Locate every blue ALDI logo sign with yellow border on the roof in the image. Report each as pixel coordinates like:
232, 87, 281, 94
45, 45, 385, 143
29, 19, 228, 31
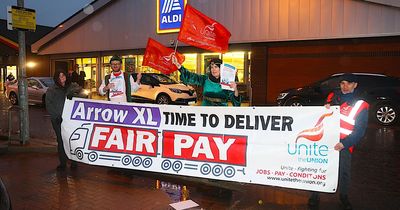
157, 0, 187, 33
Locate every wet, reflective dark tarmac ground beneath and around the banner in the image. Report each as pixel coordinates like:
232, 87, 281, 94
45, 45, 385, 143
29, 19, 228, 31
0, 92, 400, 210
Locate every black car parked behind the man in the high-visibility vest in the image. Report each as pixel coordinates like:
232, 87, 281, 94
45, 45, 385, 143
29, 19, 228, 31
277, 73, 400, 125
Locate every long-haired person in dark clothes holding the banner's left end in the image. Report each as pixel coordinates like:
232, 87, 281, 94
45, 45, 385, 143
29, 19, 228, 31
46, 70, 82, 170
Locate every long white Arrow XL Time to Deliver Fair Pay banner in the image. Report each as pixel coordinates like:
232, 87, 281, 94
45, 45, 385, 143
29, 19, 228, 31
62, 99, 339, 192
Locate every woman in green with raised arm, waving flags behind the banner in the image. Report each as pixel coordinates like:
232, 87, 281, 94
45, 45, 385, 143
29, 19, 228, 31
172, 56, 242, 106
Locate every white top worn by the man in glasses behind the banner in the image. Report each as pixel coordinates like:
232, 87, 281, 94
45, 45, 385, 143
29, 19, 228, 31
99, 73, 139, 102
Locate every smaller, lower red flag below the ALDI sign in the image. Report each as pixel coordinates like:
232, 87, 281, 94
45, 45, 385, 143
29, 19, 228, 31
142, 38, 185, 74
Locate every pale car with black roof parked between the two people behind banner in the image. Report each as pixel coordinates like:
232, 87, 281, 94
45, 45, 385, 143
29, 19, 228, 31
132, 73, 197, 105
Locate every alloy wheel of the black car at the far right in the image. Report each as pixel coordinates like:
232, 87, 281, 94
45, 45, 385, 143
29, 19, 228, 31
374, 103, 398, 125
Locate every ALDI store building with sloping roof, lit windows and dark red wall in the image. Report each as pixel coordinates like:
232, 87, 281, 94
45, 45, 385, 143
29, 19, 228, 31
32, 0, 400, 105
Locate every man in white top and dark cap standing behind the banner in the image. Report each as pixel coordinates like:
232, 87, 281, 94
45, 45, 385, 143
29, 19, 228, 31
99, 55, 142, 102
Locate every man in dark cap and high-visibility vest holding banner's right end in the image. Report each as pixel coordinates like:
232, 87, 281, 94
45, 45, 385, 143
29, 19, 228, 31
308, 73, 369, 210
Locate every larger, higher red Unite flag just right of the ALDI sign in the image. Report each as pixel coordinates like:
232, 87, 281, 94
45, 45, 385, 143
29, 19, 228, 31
178, 5, 231, 53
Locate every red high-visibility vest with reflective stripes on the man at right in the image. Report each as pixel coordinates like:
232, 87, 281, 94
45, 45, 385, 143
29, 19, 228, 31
340, 100, 369, 152
